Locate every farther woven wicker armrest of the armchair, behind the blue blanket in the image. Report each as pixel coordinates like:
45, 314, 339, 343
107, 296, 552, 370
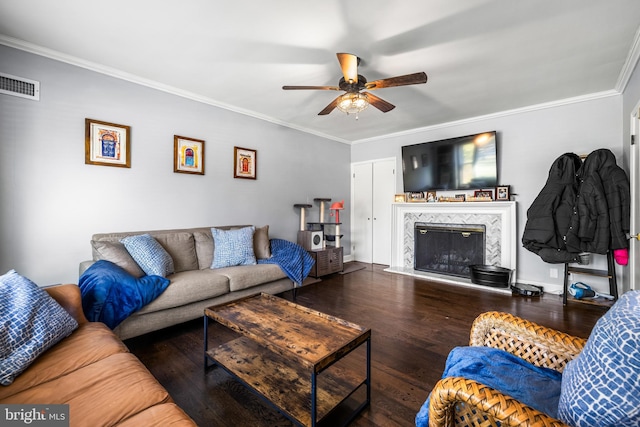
469, 311, 587, 372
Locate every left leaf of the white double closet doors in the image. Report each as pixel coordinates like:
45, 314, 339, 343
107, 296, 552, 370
351, 163, 373, 264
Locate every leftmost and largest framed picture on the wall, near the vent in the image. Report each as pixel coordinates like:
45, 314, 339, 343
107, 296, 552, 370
84, 119, 131, 168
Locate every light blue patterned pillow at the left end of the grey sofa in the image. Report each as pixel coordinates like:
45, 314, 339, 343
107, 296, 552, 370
120, 234, 175, 277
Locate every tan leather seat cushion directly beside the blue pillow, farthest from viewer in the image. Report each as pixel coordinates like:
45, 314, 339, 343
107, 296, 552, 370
0, 322, 129, 401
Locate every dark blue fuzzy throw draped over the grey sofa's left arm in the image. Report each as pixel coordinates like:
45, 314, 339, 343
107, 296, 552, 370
78, 260, 171, 329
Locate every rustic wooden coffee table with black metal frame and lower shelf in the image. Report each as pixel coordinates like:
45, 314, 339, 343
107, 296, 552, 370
204, 293, 371, 426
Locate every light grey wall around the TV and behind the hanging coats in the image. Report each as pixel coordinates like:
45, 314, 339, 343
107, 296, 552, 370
351, 95, 623, 289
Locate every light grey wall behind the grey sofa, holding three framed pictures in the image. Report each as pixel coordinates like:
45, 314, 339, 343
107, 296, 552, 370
0, 46, 350, 285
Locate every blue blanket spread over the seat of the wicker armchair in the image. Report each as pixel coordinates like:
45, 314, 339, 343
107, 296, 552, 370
416, 347, 562, 427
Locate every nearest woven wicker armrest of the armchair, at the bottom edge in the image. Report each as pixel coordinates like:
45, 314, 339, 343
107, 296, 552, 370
429, 377, 568, 427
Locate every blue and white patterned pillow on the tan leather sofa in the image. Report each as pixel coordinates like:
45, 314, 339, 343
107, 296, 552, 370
0, 270, 78, 386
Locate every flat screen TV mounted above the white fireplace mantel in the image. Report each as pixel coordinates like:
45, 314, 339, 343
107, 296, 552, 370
402, 131, 498, 192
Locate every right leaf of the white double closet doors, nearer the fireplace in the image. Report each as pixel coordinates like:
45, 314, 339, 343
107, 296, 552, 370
373, 160, 396, 265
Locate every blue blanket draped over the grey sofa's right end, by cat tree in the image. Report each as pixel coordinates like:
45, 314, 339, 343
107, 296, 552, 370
258, 239, 314, 286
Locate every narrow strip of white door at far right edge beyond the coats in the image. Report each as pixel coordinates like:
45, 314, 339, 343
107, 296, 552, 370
629, 104, 640, 290
